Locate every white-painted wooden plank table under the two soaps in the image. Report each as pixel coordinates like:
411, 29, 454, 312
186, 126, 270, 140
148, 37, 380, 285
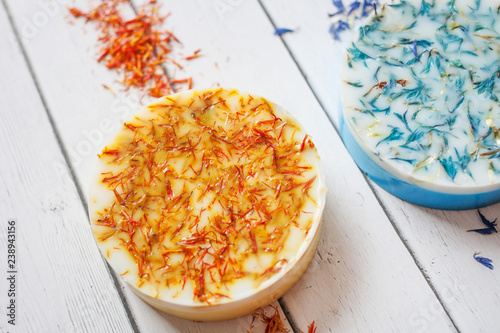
0, 0, 500, 333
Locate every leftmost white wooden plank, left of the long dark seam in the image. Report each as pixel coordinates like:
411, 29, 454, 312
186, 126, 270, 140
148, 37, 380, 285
0, 6, 133, 332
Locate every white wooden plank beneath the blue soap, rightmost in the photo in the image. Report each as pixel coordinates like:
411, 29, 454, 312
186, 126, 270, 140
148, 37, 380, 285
262, 0, 500, 332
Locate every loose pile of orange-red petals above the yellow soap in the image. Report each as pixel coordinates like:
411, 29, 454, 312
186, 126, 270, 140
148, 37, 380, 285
69, 0, 200, 97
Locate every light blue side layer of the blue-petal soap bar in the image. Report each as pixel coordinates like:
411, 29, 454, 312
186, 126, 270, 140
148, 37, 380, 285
339, 110, 500, 210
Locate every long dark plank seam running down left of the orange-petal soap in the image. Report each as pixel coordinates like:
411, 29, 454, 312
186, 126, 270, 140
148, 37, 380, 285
1, 0, 140, 333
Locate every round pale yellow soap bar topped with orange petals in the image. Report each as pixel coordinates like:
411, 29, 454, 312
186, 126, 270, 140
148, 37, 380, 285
89, 88, 326, 321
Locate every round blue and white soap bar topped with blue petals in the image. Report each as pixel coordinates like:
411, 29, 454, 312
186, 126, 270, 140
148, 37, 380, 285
340, 0, 500, 210
